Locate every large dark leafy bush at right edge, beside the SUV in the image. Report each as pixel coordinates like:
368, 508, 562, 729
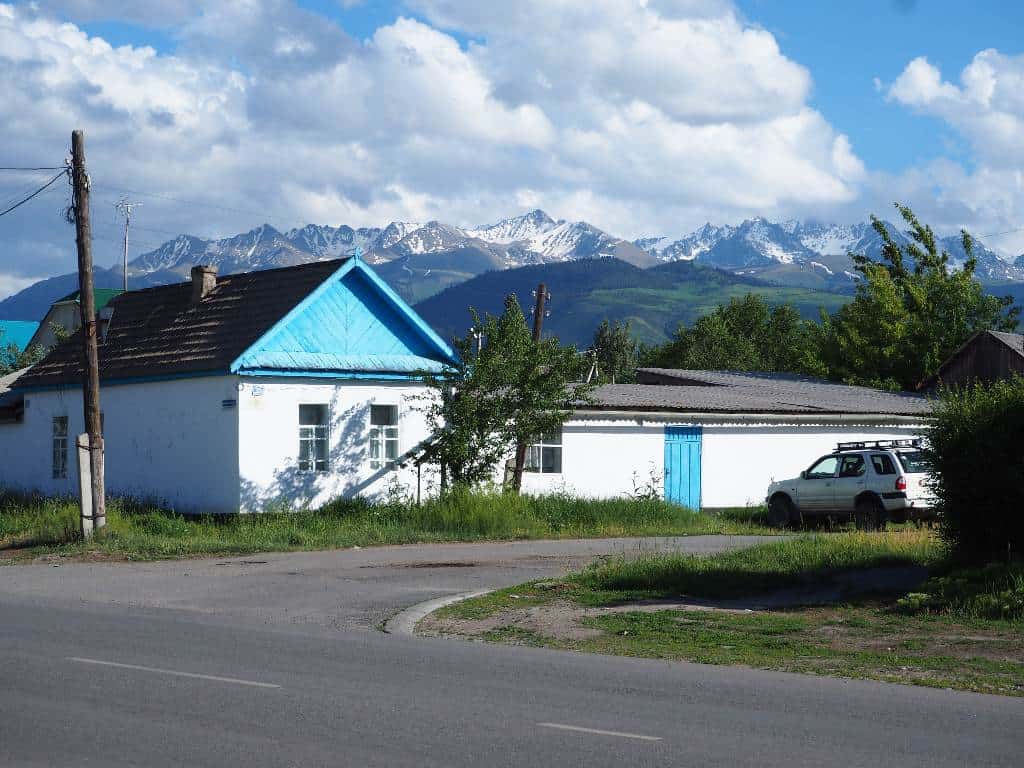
928, 377, 1024, 563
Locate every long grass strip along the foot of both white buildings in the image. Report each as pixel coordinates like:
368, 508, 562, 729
0, 493, 770, 561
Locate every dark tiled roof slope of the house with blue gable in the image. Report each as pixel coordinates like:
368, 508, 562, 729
17, 260, 342, 388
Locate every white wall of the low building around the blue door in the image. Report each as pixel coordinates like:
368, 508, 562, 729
523, 418, 922, 508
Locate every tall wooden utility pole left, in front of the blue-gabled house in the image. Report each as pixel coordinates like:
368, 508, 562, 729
71, 130, 106, 536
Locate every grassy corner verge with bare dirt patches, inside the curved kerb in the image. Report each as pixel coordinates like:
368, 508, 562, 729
420, 530, 1024, 695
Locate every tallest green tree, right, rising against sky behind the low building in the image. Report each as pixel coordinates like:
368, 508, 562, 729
818, 203, 1020, 389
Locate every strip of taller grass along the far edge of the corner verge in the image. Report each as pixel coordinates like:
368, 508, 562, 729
577, 530, 945, 597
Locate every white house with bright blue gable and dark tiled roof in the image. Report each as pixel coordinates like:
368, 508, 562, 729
0, 257, 455, 512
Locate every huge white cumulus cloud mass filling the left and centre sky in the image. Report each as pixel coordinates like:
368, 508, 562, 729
0, 0, 866, 296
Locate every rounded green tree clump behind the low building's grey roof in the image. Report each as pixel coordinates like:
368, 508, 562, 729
642, 294, 820, 373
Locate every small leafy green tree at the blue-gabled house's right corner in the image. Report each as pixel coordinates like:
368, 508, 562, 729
417, 295, 591, 489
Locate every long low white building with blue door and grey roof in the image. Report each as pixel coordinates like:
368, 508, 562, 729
523, 369, 930, 508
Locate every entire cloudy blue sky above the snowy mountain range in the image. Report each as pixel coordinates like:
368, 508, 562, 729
0, 0, 1024, 296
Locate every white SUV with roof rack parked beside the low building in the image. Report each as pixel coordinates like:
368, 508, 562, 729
766, 440, 934, 530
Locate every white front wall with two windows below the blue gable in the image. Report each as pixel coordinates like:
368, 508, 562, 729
239, 377, 436, 512
